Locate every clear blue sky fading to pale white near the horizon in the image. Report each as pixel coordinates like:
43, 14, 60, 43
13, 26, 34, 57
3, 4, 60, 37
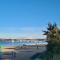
0, 0, 60, 38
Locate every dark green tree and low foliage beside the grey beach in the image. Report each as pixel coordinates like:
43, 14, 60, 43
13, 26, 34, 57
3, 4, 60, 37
32, 23, 60, 60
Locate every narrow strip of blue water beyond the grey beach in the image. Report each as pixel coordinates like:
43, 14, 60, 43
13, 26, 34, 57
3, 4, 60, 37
0, 41, 48, 47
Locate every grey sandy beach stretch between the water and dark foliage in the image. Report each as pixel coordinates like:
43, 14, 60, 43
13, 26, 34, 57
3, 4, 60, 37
15, 46, 46, 60
